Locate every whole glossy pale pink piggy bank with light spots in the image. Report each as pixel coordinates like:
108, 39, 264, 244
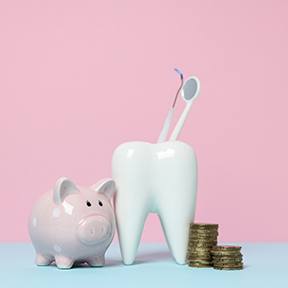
29, 177, 116, 269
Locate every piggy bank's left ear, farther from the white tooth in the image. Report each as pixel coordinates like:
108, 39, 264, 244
53, 177, 79, 204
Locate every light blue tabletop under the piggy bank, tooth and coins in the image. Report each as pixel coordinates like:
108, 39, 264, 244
0, 243, 288, 288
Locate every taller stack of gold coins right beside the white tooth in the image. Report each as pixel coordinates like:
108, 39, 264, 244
186, 223, 218, 267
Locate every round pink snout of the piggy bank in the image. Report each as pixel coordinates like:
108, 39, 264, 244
77, 215, 112, 245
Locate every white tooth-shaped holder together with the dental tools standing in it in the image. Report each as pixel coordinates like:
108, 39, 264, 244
112, 74, 199, 264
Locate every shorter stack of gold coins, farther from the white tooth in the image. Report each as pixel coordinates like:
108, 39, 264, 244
211, 246, 243, 270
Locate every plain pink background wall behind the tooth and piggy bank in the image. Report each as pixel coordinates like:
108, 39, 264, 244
0, 0, 288, 241
